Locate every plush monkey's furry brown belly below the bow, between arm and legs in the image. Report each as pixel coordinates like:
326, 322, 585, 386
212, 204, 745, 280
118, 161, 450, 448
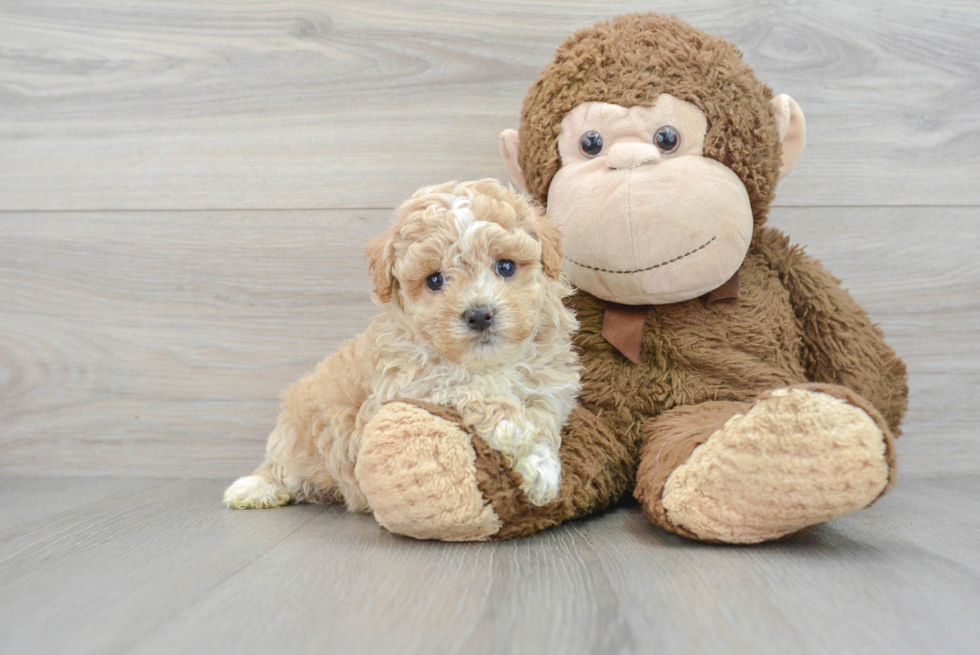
572, 252, 805, 419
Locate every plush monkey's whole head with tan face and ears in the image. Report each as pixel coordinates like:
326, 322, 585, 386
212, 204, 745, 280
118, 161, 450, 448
501, 13, 806, 305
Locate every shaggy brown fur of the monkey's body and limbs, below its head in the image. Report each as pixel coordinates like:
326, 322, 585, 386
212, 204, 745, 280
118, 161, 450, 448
466, 228, 908, 539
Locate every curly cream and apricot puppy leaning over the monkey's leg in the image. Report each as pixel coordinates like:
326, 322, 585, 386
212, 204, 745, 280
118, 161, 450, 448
224, 179, 579, 511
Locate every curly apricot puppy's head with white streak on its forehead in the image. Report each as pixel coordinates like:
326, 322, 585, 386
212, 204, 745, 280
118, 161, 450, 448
367, 179, 570, 364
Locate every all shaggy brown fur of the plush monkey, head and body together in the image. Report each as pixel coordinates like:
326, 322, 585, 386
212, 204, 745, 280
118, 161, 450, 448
475, 14, 908, 538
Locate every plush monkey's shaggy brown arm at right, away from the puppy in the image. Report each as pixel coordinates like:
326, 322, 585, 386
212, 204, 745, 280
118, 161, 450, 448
756, 228, 908, 436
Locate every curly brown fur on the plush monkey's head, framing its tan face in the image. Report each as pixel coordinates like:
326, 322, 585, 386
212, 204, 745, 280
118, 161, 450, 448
519, 13, 779, 226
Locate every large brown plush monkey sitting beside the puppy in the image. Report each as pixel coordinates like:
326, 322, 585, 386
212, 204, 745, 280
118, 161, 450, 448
358, 14, 907, 543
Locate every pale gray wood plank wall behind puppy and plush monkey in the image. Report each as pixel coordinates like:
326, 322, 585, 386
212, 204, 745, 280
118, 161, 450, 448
0, 0, 980, 477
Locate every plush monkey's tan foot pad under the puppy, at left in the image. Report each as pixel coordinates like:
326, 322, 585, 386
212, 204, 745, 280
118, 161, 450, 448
354, 402, 501, 541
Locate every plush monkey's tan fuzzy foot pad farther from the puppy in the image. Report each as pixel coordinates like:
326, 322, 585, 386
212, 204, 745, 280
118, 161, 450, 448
663, 388, 889, 543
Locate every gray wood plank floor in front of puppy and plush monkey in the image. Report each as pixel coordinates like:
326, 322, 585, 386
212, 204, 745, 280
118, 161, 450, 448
0, 476, 980, 654
